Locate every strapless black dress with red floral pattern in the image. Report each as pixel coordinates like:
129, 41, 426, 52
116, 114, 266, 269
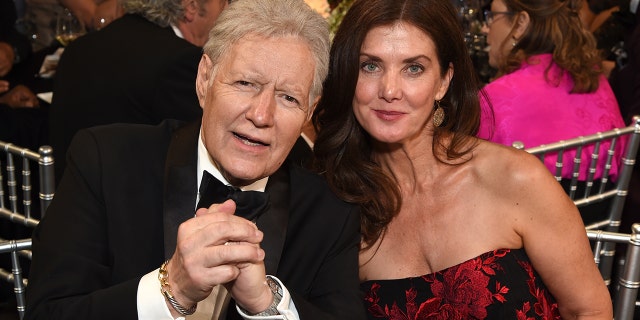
360, 249, 560, 320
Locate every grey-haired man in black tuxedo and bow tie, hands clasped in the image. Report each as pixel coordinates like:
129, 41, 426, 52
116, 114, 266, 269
26, 0, 364, 320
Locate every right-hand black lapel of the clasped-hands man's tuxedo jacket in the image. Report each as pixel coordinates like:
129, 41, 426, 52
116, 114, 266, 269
256, 162, 291, 275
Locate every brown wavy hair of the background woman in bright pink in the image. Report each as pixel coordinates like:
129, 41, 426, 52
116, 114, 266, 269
498, 0, 602, 93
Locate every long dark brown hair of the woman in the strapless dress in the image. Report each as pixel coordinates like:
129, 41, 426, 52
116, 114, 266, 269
312, 0, 480, 248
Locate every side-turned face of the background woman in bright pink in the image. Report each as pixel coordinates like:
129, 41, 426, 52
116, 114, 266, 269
484, 0, 515, 68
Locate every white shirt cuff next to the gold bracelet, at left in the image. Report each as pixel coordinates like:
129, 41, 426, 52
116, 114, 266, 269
137, 269, 184, 320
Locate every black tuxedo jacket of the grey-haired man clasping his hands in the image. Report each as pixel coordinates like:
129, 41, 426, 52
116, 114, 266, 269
27, 121, 364, 320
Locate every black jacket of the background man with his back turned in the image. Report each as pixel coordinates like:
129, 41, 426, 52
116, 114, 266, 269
49, 14, 202, 181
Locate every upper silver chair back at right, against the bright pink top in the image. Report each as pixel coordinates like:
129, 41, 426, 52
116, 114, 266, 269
512, 116, 640, 285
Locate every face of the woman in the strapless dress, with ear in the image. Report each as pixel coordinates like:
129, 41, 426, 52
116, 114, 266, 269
353, 23, 453, 143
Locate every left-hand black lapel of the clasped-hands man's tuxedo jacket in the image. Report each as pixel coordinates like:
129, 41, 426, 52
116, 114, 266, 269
163, 122, 200, 259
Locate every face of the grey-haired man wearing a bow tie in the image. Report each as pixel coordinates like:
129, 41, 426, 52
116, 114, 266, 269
196, 36, 318, 185
